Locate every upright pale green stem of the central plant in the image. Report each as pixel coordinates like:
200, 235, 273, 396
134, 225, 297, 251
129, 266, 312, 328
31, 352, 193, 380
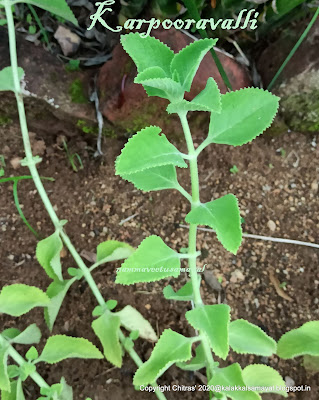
179, 113, 215, 381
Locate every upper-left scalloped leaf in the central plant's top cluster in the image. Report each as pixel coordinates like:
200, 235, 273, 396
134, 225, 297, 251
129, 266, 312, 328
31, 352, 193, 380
121, 32, 174, 77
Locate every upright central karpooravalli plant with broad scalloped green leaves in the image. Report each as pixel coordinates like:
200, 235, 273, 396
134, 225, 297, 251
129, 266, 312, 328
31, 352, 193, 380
115, 33, 319, 400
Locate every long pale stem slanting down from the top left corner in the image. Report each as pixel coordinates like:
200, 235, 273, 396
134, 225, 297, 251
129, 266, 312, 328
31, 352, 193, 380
3, 0, 165, 400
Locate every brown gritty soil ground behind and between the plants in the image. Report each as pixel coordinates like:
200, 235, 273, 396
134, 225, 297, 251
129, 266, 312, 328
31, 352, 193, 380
0, 124, 319, 400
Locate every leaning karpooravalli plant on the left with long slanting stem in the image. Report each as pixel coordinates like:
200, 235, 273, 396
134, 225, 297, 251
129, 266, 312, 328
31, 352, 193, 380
0, 0, 164, 400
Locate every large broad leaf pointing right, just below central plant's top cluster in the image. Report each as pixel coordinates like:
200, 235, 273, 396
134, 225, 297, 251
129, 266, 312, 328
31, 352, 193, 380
207, 88, 279, 146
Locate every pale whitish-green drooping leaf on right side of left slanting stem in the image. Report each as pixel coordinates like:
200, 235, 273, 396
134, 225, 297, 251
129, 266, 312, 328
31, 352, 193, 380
114, 306, 157, 342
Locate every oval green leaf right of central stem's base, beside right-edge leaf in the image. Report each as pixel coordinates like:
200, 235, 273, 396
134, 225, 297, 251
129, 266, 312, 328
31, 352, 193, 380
229, 319, 277, 357
